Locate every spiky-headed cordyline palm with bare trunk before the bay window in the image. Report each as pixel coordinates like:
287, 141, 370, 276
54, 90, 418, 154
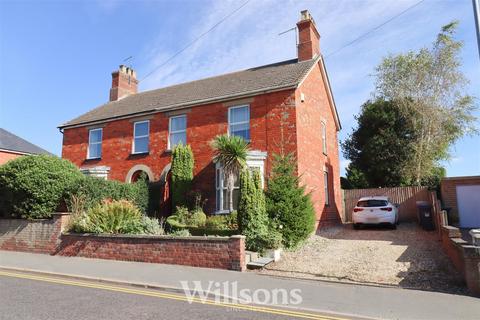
211, 135, 249, 212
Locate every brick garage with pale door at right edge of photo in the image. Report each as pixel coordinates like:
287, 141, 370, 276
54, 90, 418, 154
440, 176, 480, 229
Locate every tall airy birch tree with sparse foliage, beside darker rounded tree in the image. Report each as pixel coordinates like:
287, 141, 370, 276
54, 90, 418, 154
375, 22, 477, 185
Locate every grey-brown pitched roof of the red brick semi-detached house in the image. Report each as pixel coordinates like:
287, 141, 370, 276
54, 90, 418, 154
60, 59, 318, 128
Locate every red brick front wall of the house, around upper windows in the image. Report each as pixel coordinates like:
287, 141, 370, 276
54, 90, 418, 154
62, 90, 296, 212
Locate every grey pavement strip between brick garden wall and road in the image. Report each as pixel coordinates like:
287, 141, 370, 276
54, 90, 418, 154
0, 251, 480, 319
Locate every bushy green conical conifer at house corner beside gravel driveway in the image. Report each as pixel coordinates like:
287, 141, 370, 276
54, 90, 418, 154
266, 154, 315, 248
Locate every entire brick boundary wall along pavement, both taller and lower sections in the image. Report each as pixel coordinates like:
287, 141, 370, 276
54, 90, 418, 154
0, 213, 246, 271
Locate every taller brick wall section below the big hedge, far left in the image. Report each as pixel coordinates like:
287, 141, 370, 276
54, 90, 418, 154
0, 214, 68, 253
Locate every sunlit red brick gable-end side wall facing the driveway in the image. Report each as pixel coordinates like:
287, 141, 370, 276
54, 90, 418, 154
296, 64, 342, 223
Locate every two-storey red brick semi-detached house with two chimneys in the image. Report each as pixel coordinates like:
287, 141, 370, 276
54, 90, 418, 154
59, 11, 342, 223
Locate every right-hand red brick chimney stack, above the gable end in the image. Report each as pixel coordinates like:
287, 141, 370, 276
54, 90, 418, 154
297, 10, 320, 61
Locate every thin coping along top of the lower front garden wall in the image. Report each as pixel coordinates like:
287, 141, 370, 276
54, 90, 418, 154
62, 232, 245, 242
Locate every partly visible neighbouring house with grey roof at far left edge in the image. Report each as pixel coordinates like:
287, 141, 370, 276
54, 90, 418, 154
0, 128, 50, 165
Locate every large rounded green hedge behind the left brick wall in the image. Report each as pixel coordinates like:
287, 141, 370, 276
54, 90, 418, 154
0, 155, 149, 219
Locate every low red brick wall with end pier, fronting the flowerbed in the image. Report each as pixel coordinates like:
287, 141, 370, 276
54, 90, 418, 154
58, 234, 246, 271
